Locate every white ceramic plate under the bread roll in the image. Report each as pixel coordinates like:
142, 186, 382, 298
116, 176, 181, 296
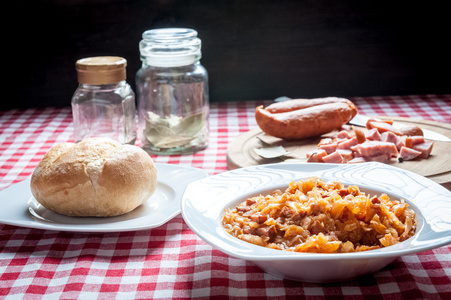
0, 163, 208, 232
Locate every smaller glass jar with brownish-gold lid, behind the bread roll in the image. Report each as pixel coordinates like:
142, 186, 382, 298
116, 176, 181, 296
72, 56, 136, 145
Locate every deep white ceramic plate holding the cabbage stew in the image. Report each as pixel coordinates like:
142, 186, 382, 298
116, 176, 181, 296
182, 162, 451, 282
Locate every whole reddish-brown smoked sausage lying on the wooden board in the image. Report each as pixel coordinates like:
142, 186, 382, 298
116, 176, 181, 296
255, 97, 357, 139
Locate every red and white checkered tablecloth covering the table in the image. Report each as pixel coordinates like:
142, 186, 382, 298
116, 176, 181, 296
0, 95, 451, 299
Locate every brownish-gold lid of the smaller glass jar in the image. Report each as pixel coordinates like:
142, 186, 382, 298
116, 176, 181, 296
75, 56, 127, 84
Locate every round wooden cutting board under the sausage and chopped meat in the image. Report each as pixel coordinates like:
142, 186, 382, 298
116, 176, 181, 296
227, 116, 451, 189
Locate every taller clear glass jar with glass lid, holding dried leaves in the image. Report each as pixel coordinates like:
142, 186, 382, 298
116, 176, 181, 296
136, 28, 209, 155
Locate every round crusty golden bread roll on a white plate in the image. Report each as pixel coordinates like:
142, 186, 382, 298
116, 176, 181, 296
30, 138, 157, 217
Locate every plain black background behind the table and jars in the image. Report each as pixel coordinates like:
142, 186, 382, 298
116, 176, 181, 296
4, 0, 451, 110
